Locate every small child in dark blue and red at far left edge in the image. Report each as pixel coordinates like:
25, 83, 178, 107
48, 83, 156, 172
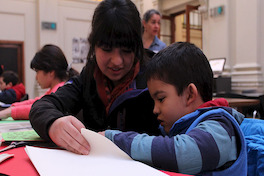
0, 71, 25, 104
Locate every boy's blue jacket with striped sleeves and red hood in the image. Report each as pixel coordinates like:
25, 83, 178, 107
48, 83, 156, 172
105, 89, 247, 176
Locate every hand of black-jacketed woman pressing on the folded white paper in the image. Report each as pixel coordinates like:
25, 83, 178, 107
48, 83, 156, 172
49, 116, 90, 155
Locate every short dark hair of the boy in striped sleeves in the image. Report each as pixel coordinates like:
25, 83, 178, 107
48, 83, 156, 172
146, 42, 213, 102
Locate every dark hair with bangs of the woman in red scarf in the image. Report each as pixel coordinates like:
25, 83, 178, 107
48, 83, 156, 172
87, 0, 144, 62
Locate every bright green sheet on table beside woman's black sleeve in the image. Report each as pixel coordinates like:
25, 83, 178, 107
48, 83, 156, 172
2, 130, 43, 141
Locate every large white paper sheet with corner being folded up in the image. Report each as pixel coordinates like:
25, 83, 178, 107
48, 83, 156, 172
25, 129, 166, 176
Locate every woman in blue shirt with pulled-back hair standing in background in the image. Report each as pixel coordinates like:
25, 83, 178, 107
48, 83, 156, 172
142, 9, 166, 53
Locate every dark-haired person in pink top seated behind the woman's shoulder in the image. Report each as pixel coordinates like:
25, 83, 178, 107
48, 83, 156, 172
0, 45, 77, 120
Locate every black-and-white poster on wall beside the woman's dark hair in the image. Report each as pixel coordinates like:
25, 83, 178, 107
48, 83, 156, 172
72, 38, 89, 64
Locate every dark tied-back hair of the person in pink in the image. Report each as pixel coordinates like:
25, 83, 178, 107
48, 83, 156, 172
30, 44, 78, 81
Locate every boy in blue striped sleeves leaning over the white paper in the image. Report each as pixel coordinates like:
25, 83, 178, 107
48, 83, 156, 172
101, 42, 247, 176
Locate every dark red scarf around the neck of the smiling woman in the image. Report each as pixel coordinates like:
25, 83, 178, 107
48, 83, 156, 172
94, 62, 140, 114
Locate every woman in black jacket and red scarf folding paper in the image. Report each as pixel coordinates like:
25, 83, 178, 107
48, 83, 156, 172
29, 0, 158, 154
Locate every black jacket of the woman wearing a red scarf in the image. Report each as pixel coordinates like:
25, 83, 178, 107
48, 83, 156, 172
29, 62, 159, 140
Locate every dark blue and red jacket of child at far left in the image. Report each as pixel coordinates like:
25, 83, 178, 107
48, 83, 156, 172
0, 83, 25, 104
